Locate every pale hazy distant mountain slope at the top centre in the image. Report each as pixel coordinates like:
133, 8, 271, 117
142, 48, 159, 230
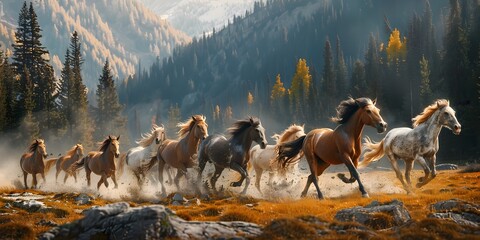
137, 0, 255, 36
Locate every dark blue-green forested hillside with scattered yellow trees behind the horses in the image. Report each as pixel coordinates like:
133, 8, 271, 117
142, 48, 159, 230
120, 0, 480, 161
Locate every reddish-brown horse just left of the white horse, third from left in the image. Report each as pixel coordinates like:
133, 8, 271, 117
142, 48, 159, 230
69, 136, 120, 189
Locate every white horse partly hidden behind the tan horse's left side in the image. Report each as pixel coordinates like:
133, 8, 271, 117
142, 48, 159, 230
119, 124, 166, 186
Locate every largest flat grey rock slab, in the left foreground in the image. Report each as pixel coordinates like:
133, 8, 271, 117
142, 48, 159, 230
39, 202, 261, 239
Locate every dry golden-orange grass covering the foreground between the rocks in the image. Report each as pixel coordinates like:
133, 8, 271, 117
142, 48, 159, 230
0, 171, 480, 239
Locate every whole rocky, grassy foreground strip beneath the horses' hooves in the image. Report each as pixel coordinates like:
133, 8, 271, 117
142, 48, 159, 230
0, 164, 480, 239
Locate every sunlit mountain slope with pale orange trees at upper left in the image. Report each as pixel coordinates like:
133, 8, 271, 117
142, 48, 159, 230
0, 0, 190, 87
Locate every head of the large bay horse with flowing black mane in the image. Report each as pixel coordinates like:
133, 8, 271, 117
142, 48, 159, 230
355, 99, 387, 133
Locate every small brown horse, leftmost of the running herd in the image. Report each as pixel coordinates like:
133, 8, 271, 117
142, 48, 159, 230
20, 139, 56, 189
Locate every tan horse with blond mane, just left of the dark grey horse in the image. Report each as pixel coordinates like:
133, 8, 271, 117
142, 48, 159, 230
153, 115, 208, 193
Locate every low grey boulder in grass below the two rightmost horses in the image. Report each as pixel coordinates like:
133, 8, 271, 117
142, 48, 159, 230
335, 200, 411, 229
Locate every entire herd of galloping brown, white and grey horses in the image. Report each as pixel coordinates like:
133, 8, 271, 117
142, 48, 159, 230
20, 98, 461, 199
